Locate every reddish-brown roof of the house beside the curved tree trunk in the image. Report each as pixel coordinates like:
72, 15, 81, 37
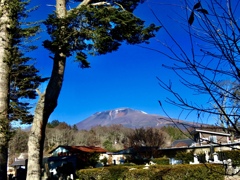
49, 146, 107, 154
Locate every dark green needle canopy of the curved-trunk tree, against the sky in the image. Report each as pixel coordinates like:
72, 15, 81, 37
43, 1, 159, 68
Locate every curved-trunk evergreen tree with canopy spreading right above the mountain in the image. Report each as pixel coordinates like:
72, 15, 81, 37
27, 0, 159, 180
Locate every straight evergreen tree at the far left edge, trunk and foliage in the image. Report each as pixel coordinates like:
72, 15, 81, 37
0, 0, 46, 180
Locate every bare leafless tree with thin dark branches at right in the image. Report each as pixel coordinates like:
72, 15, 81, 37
145, 0, 240, 137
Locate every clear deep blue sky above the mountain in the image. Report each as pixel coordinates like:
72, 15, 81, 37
19, 0, 212, 125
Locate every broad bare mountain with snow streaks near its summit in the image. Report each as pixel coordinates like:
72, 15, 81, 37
76, 108, 199, 130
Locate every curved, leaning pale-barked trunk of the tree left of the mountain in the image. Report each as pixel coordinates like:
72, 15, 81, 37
27, 0, 66, 180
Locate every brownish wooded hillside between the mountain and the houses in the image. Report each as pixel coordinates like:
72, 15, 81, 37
9, 120, 189, 164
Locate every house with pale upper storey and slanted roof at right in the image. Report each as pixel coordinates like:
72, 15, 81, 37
159, 128, 240, 157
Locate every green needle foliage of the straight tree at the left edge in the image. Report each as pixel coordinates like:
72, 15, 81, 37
6, 0, 47, 123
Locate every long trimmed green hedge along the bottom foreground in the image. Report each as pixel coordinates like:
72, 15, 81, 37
77, 164, 224, 180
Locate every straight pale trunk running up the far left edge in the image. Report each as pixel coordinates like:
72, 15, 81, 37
0, 0, 9, 180
